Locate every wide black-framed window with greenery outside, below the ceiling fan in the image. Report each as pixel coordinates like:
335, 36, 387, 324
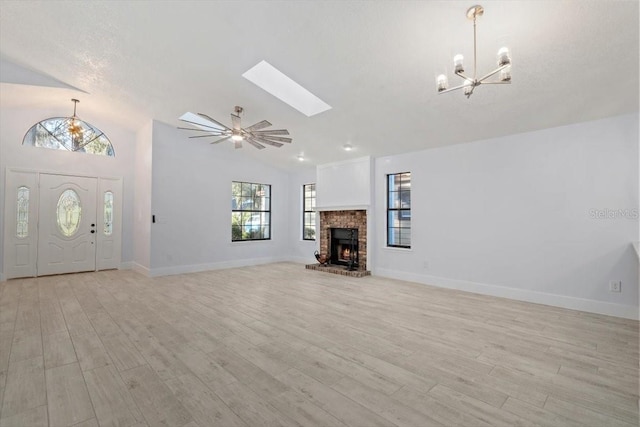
231, 181, 271, 242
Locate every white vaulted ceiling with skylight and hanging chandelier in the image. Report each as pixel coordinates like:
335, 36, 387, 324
0, 0, 639, 169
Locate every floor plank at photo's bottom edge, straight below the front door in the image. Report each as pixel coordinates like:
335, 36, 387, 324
45, 363, 94, 426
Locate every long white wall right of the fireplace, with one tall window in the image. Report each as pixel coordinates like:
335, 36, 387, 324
374, 114, 638, 318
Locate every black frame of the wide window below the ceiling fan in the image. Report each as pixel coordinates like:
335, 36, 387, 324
231, 181, 273, 242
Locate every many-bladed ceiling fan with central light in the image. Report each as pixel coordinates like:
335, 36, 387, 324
178, 106, 292, 150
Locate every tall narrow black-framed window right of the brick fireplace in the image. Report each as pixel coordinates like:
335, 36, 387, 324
387, 172, 411, 248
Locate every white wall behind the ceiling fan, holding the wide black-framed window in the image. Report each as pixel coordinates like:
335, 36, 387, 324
146, 122, 293, 275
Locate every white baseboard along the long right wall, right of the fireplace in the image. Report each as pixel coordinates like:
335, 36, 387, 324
372, 269, 640, 320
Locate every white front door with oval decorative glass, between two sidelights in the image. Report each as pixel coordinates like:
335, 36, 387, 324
37, 174, 98, 276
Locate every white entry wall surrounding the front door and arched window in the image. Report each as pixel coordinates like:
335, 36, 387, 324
0, 108, 136, 277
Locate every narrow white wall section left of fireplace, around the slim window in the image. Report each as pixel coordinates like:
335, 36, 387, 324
288, 167, 320, 264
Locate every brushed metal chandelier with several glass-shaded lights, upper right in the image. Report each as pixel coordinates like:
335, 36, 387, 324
436, 5, 511, 98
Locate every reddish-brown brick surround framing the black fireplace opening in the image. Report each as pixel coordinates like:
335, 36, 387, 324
320, 210, 367, 270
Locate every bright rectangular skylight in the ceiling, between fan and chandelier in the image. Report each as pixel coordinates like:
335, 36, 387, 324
242, 61, 331, 117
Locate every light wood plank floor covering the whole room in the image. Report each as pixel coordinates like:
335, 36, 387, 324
0, 263, 638, 427
